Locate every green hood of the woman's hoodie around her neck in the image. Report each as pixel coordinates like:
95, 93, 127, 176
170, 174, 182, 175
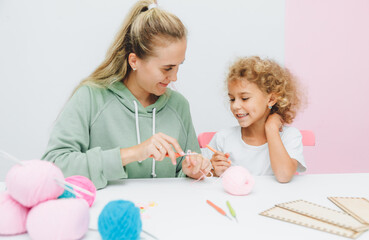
108, 81, 172, 115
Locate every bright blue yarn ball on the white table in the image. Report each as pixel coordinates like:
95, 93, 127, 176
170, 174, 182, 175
98, 200, 142, 240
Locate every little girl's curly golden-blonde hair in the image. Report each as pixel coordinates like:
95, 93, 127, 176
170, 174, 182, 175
226, 56, 301, 124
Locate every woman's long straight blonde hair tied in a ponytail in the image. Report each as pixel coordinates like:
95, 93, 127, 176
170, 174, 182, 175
74, 0, 187, 92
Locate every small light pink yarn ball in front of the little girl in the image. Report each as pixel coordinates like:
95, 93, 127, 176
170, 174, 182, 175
222, 166, 255, 195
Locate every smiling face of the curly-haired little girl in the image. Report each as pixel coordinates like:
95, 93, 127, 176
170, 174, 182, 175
228, 79, 271, 128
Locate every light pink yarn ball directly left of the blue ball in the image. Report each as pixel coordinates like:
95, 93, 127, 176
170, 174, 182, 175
26, 198, 90, 240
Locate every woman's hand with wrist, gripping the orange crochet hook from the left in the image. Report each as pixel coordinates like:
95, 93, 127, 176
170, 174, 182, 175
120, 133, 184, 166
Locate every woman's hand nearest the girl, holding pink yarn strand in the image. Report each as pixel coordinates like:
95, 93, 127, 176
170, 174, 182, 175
182, 154, 211, 179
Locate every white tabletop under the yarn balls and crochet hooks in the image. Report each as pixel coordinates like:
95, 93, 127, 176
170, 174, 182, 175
0, 173, 369, 240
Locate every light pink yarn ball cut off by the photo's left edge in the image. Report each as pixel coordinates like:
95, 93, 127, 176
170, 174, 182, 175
0, 192, 29, 235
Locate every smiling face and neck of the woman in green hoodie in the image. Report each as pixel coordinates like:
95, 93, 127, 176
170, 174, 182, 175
131, 39, 187, 97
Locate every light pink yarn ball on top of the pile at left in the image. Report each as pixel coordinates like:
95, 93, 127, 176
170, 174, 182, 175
6, 160, 64, 207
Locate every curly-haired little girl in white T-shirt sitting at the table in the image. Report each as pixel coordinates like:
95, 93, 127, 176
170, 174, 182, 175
204, 57, 306, 182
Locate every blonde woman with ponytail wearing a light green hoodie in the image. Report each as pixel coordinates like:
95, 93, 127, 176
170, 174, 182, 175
43, 0, 211, 188
